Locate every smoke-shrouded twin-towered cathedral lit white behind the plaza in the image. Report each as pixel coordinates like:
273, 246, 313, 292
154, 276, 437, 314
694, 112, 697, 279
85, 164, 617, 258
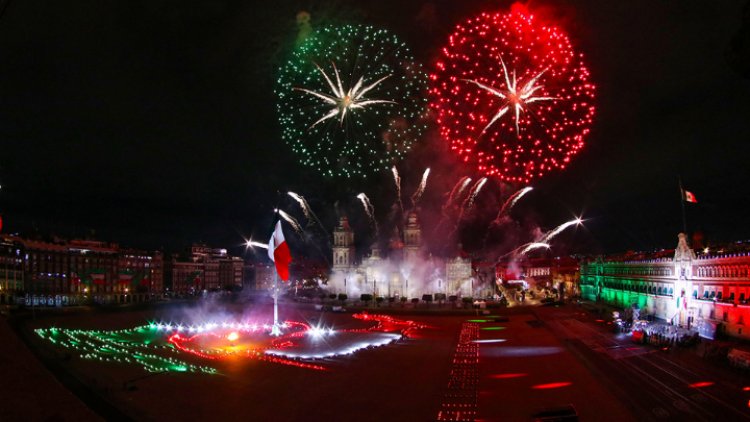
328, 212, 475, 299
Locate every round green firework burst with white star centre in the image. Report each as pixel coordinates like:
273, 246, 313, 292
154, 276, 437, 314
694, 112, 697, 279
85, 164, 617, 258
276, 25, 427, 177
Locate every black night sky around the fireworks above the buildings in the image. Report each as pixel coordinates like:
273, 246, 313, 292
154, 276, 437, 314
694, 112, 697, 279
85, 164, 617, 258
0, 0, 750, 257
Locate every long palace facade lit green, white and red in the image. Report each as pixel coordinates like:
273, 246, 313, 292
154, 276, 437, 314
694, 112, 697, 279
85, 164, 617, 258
581, 233, 750, 338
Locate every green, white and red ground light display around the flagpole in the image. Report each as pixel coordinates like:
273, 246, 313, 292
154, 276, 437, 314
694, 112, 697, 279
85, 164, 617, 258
36, 313, 427, 374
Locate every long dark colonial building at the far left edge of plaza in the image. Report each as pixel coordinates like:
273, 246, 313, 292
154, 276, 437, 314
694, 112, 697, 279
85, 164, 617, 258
0, 236, 163, 306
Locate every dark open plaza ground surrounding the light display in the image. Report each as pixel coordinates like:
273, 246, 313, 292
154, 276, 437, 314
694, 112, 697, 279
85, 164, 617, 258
0, 304, 750, 421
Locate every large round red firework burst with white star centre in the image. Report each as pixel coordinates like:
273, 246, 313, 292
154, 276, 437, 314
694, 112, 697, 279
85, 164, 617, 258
430, 10, 595, 182
